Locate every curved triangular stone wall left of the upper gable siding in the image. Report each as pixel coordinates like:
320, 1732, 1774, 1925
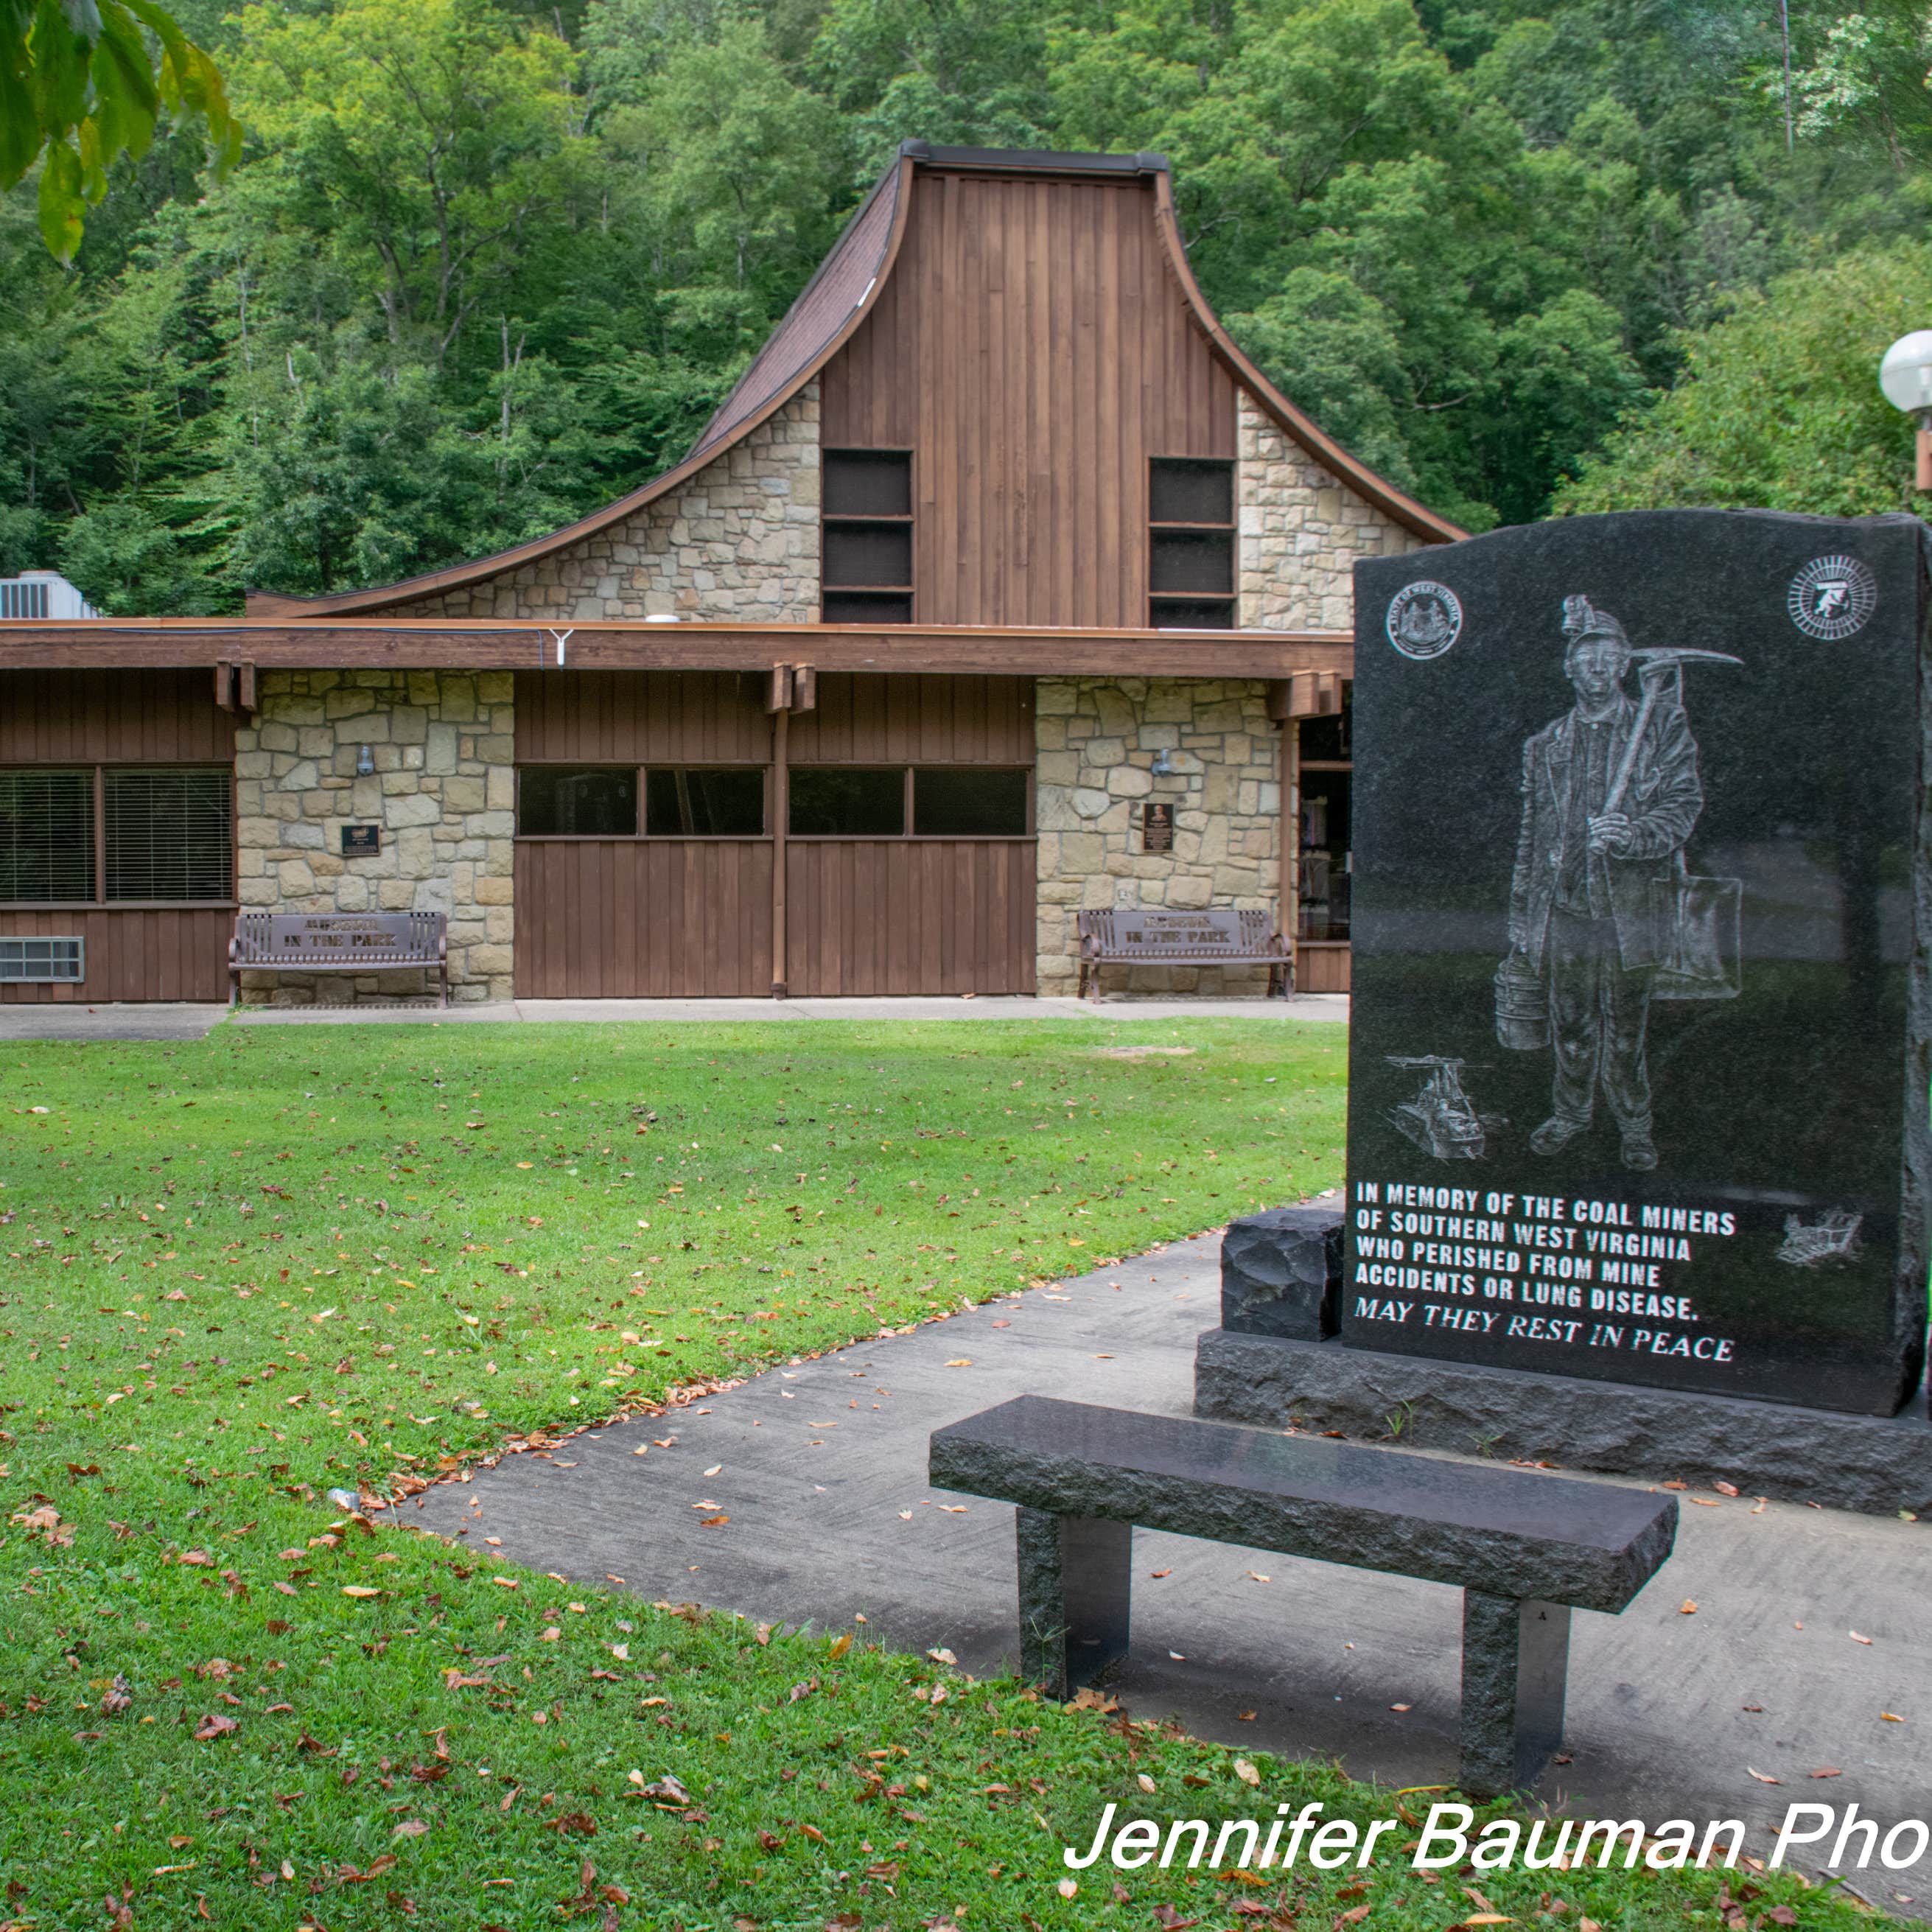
394, 382, 819, 624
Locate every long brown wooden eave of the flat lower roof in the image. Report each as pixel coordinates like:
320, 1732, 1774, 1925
0, 618, 1354, 678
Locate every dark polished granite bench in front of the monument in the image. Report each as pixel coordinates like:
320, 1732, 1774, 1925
929, 1395, 1677, 1796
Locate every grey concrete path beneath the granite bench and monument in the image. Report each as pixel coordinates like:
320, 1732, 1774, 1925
411, 1234, 1932, 1917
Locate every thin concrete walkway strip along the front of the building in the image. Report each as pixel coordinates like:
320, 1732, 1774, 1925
238, 993, 1348, 1026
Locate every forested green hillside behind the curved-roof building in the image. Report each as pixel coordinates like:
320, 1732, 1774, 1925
0, 0, 1932, 612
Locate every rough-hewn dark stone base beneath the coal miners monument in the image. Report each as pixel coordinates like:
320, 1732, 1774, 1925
1194, 1329, 1932, 1516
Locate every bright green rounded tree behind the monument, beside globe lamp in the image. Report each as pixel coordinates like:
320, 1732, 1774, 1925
1557, 242, 1932, 516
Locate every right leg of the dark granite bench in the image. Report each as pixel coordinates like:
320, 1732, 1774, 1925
1460, 1590, 1569, 1799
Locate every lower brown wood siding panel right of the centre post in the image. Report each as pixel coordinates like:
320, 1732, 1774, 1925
786, 839, 1035, 999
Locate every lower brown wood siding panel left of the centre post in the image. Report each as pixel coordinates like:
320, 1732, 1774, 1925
516, 839, 771, 999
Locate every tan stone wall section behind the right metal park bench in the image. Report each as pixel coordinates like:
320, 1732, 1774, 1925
1034, 678, 1281, 997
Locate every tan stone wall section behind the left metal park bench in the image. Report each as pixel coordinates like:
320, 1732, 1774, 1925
236, 671, 516, 1007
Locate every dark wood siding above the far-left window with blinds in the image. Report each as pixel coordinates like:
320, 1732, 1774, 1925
0, 668, 236, 765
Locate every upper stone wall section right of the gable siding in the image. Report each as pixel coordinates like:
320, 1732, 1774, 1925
1236, 391, 1422, 630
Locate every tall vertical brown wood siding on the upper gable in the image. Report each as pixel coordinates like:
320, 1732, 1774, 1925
821, 174, 1234, 626
